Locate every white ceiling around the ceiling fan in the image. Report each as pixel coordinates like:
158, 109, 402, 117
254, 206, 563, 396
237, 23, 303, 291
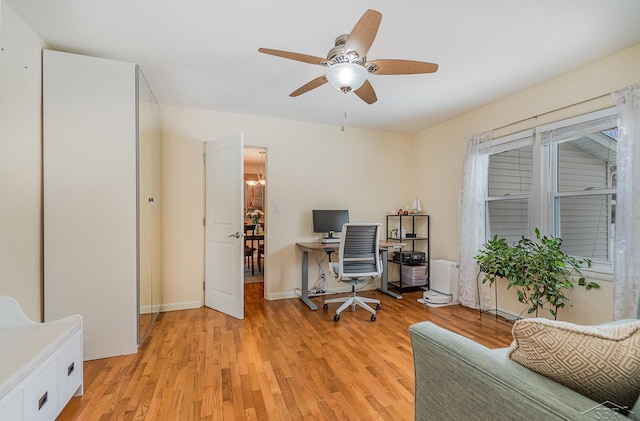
5, 0, 640, 133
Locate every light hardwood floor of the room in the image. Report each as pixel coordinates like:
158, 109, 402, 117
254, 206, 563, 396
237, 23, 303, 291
58, 283, 511, 420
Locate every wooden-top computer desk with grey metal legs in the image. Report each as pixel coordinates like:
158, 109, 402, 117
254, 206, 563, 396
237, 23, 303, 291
296, 240, 407, 310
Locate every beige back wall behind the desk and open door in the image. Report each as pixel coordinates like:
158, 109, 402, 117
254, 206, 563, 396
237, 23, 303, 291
162, 106, 415, 309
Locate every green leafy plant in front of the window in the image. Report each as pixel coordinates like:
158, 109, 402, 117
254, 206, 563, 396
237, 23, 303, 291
474, 228, 600, 319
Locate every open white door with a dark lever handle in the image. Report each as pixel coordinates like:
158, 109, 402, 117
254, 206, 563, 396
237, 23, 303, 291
204, 133, 244, 319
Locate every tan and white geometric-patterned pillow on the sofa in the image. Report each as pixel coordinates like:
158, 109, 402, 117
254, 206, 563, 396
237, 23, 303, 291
507, 318, 640, 408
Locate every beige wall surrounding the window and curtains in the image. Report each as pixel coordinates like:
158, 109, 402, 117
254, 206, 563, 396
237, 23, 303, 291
415, 44, 640, 323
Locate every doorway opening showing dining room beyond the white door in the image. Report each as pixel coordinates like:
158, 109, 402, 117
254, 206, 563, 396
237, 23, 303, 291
243, 146, 267, 284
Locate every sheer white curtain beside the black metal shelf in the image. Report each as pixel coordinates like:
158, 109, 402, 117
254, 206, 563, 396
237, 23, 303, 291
458, 132, 492, 308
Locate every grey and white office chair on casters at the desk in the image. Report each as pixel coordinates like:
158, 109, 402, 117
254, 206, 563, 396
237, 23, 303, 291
322, 224, 382, 322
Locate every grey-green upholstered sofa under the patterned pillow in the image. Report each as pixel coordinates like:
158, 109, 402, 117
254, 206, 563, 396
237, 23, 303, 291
409, 309, 640, 421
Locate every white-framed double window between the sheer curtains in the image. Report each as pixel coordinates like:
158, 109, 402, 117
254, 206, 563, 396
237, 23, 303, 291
486, 109, 618, 265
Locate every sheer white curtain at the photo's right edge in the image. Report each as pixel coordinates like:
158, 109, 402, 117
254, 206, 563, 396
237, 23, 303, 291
612, 84, 640, 320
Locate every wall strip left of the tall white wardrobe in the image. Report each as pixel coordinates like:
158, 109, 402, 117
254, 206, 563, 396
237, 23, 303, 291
0, 2, 44, 321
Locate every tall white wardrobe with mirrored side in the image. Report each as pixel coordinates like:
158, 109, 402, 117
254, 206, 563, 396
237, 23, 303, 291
43, 50, 162, 360
